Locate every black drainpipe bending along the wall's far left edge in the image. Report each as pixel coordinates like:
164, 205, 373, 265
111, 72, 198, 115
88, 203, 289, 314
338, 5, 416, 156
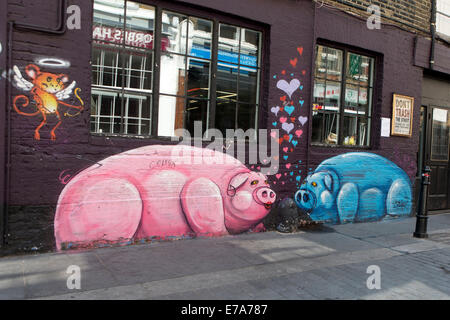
1, 0, 67, 246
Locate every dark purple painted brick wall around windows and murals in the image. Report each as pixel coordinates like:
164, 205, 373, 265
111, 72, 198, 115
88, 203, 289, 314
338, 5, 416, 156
2, 0, 422, 255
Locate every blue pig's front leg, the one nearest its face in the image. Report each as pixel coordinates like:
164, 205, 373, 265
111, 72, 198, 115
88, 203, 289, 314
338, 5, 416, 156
336, 182, 359, 223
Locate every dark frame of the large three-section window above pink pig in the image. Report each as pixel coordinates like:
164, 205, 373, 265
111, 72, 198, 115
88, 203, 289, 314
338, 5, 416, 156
89, 0, 269, 141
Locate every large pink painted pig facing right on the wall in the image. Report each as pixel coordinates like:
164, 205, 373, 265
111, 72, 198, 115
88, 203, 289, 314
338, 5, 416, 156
54, 145, 276, 250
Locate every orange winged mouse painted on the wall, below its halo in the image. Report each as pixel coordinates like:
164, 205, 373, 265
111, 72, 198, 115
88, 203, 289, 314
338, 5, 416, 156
13, 64, 84, 141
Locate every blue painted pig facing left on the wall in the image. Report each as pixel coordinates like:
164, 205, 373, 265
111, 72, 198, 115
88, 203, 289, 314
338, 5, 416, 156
295, 152, 412, 224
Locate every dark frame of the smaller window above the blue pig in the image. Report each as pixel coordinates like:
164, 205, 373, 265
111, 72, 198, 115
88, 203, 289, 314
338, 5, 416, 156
309, 39, 382, 150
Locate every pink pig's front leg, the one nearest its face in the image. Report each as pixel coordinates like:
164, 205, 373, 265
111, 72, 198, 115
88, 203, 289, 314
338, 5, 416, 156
181, 178, 228, 236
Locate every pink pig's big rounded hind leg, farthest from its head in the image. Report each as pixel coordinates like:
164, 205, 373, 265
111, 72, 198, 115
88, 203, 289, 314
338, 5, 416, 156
55, 176, 142, 250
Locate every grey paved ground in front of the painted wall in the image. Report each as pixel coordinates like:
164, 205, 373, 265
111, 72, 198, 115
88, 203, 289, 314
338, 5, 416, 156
0, 213, 450, 300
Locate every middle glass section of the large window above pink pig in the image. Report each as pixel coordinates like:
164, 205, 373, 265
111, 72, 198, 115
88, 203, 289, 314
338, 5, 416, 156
158, 11, 212, 136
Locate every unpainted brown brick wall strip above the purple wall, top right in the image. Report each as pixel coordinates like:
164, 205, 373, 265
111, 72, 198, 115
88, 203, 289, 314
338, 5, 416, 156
316, 0, 431, 34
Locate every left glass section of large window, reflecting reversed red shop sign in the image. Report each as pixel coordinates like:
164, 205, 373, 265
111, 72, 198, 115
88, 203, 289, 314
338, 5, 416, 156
91, 0, 155, 135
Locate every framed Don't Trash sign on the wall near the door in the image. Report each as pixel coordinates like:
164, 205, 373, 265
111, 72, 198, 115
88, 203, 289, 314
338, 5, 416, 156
391, 94, 414, 137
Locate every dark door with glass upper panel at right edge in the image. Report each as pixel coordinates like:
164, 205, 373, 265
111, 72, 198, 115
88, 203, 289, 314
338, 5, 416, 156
424, 106, 450, 210
